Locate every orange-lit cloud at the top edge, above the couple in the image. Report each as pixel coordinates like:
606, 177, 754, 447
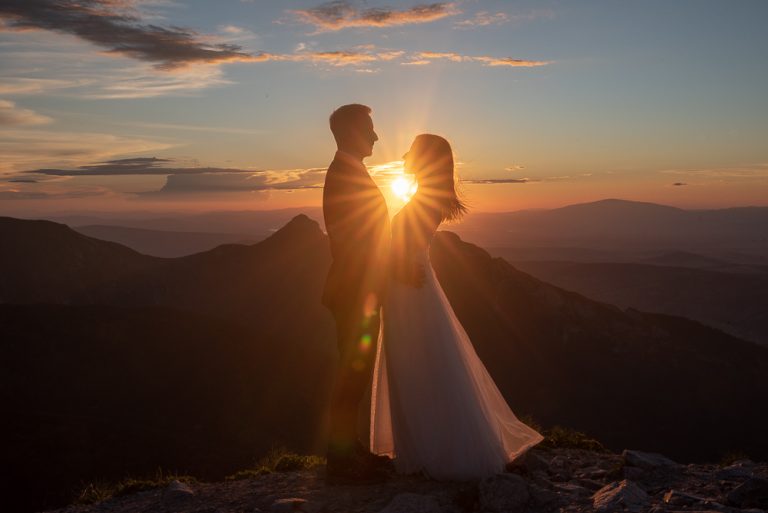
289, 0, 460, 32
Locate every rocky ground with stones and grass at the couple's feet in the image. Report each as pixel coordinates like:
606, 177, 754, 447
45, 448, 768, 513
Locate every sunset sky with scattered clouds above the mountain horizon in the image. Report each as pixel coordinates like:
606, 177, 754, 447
0, 0, 768, 215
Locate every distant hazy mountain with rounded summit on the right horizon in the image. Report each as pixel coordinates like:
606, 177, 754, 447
455, 199, 768, 258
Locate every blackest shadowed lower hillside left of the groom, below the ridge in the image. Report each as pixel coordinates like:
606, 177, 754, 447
0, 305, 332, 511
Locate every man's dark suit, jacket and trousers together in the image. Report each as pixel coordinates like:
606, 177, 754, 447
322, 151, 391, 459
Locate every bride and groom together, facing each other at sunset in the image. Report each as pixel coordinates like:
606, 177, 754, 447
323, 104, 542, 483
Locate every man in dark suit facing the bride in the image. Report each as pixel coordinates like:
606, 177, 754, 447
322, 104, 391, 483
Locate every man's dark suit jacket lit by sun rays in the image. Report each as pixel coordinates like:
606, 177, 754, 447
322, 151, 391, 315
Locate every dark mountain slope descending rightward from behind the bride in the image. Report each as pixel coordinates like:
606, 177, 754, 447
432, 232, 768, 460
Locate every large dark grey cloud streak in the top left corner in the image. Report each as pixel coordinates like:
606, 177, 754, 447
0, 0, 260, 70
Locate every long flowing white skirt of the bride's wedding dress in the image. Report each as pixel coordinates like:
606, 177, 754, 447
370, 240, 543, 481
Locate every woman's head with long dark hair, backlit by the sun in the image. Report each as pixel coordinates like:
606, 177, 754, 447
403, 134, 467, 221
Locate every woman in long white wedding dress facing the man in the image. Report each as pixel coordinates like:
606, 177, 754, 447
370, 134, 543, 481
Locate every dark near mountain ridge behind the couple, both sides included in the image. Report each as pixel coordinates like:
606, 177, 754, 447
0, 210, 768, 507
